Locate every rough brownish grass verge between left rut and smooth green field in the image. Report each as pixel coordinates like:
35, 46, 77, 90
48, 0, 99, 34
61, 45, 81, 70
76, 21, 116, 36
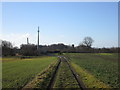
23, 61, 59, 90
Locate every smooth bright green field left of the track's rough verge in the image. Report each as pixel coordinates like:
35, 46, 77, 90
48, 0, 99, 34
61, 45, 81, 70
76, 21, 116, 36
2, 56, 57, 88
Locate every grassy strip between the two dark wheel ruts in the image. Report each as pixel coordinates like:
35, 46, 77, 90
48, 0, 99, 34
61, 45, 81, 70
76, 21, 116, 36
53, 57, 80, 88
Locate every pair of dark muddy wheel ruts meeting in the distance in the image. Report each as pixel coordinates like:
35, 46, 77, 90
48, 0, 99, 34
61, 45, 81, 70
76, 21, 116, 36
47, 56, 86, 90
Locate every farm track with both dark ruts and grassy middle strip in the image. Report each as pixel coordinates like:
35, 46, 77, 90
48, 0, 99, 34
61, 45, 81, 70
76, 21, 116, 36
48, 56, 85, 90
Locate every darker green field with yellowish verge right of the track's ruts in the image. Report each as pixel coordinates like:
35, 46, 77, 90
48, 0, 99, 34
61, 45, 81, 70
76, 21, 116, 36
64, 53, 118, 88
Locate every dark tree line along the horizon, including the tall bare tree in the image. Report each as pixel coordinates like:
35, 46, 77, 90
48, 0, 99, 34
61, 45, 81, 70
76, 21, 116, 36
1, 37, 120, 56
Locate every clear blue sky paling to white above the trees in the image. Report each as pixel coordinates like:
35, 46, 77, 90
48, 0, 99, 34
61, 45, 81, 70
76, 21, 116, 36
0, 2, 118, 48
